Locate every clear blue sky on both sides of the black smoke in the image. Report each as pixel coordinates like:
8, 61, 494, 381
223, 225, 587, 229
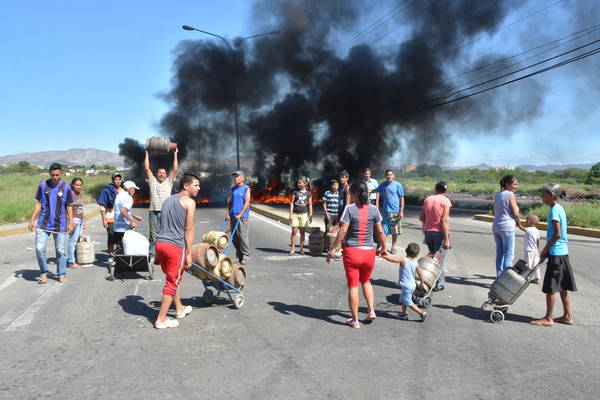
0, 0, 600, 166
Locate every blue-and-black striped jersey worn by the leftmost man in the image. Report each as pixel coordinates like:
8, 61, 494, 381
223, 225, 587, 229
35, 179, 75, 232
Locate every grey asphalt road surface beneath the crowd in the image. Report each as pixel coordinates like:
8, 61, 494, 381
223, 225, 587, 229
0, 208, 600, 400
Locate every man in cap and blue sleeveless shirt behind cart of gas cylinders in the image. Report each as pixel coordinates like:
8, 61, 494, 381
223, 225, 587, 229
225, 170, 250, 265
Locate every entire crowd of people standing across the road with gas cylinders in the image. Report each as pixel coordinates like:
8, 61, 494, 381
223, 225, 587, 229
29, 155, 577, 329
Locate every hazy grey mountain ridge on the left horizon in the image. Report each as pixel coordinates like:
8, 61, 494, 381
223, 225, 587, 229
0, 149, 125, 167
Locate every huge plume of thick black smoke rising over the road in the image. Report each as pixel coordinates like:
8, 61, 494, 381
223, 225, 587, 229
120, 0, 596, 179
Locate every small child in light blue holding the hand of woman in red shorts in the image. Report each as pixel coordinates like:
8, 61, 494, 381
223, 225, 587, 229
382, 243, 427, 321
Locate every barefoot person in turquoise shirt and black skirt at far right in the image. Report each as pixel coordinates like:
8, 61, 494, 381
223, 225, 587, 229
531, 183, 577, 326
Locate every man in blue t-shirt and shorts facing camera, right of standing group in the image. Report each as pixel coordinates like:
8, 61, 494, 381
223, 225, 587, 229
377, 169, 404, 254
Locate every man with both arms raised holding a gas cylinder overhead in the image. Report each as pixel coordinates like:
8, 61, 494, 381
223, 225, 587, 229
144, 148, 179, 260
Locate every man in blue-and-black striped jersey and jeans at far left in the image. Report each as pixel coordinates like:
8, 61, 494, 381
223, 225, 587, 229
28, 163, 75, 283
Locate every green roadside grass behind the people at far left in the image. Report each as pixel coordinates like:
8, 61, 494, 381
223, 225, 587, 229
0, 172, 110, 224
